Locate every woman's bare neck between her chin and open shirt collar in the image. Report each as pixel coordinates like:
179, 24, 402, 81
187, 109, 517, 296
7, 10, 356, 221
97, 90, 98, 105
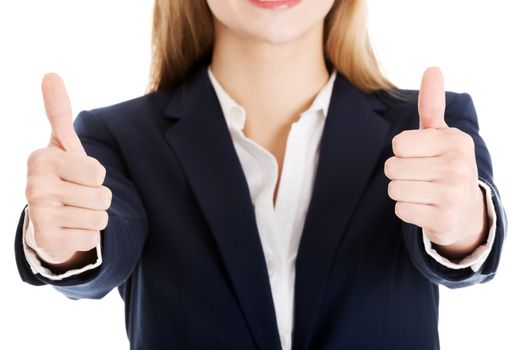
211, 19, 329, 128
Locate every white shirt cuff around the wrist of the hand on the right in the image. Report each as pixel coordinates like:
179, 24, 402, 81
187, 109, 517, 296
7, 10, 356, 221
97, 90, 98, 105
422, 180, 497, 272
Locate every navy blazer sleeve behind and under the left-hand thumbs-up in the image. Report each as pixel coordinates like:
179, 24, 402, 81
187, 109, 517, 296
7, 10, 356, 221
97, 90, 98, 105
15, 111, 148, 299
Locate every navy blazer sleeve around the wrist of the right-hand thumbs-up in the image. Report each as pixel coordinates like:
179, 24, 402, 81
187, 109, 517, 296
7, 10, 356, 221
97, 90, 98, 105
402, 92, 508, 288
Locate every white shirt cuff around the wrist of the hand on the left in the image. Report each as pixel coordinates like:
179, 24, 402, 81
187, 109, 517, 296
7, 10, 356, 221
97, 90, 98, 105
22, 207, 102, 281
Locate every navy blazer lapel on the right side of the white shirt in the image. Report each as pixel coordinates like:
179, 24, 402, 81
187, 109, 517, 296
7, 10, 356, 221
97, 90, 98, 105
292, 74, 390, 350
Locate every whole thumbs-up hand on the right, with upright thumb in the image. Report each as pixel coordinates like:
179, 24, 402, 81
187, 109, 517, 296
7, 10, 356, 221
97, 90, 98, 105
384, 68, 487, 258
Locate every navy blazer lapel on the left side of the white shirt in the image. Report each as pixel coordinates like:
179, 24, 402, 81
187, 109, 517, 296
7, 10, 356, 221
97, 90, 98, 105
165, 65, 280, 350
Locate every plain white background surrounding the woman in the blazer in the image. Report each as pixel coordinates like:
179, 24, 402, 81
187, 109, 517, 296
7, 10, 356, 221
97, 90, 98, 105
0, 0, 524, 350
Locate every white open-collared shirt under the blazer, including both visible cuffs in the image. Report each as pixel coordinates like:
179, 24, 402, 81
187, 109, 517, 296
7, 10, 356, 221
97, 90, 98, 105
23, 67, 496, 350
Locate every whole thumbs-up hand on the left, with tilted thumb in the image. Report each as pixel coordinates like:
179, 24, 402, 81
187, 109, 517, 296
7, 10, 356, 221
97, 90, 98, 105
25, 73, 112, 265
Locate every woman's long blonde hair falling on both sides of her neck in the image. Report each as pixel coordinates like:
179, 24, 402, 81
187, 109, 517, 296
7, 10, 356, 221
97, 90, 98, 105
149, 0, 395, 92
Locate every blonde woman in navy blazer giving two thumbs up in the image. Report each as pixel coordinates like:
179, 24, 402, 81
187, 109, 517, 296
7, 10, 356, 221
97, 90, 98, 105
15, 0, 507, 350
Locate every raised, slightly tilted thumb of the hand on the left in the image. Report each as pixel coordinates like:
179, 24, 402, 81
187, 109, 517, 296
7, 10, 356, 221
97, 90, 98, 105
42, 73, 86, 154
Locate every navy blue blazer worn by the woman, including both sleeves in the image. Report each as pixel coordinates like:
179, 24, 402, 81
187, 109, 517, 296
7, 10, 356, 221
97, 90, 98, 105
15, 65, 507, 350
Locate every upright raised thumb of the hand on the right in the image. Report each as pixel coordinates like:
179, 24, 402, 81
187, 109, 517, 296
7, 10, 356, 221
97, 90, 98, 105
418, 67, 448, 129
